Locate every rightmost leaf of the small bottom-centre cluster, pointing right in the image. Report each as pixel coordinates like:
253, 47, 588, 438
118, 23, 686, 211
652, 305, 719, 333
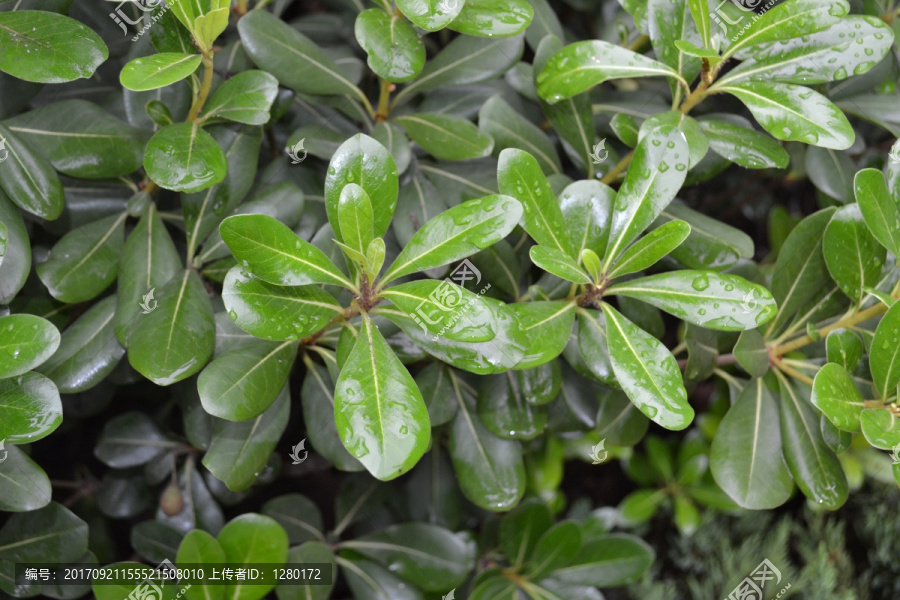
553, 533, 655, 588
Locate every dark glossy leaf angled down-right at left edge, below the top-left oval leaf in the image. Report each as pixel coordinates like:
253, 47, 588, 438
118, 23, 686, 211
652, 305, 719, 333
0, 125, 65, 221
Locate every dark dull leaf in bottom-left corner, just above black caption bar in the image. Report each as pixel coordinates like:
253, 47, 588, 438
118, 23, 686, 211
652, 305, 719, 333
0, 502, 88, 563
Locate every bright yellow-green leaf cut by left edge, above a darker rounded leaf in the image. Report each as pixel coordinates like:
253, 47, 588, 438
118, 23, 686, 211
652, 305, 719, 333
0, 314, 60, 380
